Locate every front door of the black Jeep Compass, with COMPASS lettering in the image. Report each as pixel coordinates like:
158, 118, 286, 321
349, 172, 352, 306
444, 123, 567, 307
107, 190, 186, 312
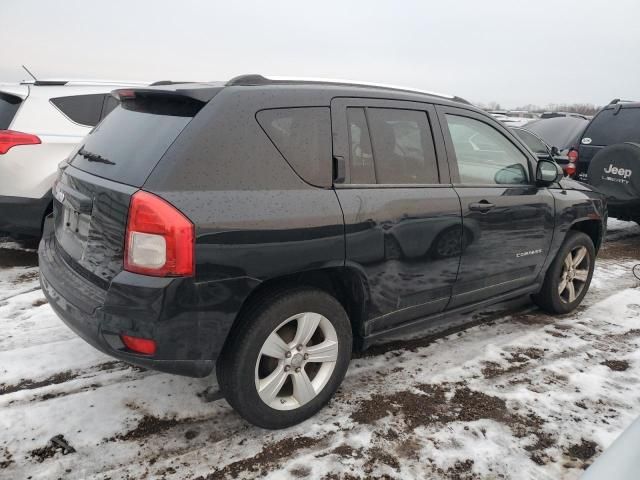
438, 107, 554, 308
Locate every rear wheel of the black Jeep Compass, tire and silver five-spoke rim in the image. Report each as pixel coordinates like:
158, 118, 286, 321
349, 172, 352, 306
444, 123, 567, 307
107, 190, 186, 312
217, 287, 352, 429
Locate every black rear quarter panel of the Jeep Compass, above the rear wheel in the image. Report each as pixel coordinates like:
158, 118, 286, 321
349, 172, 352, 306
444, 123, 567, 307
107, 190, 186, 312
143, 87, 345, 342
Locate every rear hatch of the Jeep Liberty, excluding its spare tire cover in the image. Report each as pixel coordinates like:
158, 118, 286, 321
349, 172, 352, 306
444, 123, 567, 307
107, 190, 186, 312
577, 104, 640, 182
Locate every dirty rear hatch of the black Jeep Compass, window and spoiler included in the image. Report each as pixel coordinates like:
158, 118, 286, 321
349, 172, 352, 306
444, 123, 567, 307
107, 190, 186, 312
53, 89, 218, 289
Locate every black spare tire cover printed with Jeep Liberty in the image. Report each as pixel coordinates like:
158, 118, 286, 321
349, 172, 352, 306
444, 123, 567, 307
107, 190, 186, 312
588, 142, 640, 204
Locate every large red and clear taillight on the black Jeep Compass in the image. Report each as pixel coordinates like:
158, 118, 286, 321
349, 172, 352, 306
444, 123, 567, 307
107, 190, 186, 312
124, 190, 195, 277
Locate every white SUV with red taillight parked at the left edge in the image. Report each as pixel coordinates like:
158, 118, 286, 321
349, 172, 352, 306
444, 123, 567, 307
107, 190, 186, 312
0, 80, 149, 237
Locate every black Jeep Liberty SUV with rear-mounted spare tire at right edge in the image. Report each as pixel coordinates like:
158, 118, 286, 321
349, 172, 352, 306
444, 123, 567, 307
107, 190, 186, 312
577, 99, 640, 223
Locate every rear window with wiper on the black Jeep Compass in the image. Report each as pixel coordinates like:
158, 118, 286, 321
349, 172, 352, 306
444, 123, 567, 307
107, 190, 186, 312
71, 98, 202, 187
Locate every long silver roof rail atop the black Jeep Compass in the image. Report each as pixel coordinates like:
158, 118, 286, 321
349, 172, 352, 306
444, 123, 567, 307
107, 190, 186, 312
225, 73, 471, 105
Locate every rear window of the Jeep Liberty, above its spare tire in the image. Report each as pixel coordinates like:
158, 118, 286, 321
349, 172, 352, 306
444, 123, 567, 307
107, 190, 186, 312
583, 107, 640, 146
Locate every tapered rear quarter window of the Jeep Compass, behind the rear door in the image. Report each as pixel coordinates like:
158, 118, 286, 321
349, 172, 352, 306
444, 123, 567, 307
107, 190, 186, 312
256, 107, 332, 187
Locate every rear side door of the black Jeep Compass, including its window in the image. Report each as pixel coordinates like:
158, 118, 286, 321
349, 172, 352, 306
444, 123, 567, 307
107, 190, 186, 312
331, 98, 462, 335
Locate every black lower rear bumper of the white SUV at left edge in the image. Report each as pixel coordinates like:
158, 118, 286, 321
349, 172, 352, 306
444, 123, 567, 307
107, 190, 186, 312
0, 191, 51, 237
